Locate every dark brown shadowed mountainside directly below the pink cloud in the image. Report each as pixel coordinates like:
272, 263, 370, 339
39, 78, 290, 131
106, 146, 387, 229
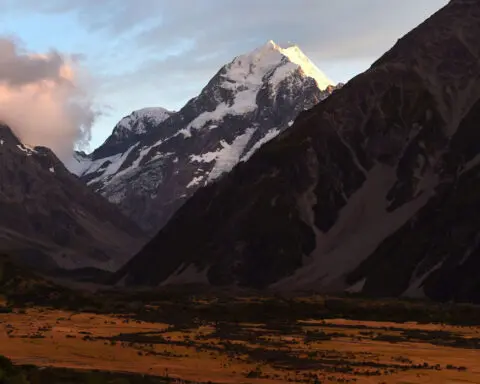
0, 125, 145, 270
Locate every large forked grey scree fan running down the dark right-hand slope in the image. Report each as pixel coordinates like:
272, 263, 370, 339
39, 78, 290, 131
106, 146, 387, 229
272, 164, 438, 291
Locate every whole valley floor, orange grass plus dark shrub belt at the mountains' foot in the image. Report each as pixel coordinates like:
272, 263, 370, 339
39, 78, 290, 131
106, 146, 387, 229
0, 254, 480, 384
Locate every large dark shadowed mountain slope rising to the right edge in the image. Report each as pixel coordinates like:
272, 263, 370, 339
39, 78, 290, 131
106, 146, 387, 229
111, 1, 480, 302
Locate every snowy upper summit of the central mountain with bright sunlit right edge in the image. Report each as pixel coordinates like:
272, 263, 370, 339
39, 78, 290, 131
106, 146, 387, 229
177, 40, 333, 138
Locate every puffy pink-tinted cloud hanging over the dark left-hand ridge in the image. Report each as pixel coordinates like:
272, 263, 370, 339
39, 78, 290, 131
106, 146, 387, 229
0, 38, 96, 159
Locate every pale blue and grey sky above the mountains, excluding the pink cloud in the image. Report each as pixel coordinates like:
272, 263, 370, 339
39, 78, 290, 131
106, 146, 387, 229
0, 0, 448, 152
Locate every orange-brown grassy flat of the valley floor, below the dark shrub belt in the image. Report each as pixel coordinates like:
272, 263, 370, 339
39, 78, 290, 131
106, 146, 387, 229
0, 307, 480, 384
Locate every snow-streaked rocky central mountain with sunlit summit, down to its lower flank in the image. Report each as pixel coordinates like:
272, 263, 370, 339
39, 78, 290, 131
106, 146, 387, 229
68, 42, 336, 233
